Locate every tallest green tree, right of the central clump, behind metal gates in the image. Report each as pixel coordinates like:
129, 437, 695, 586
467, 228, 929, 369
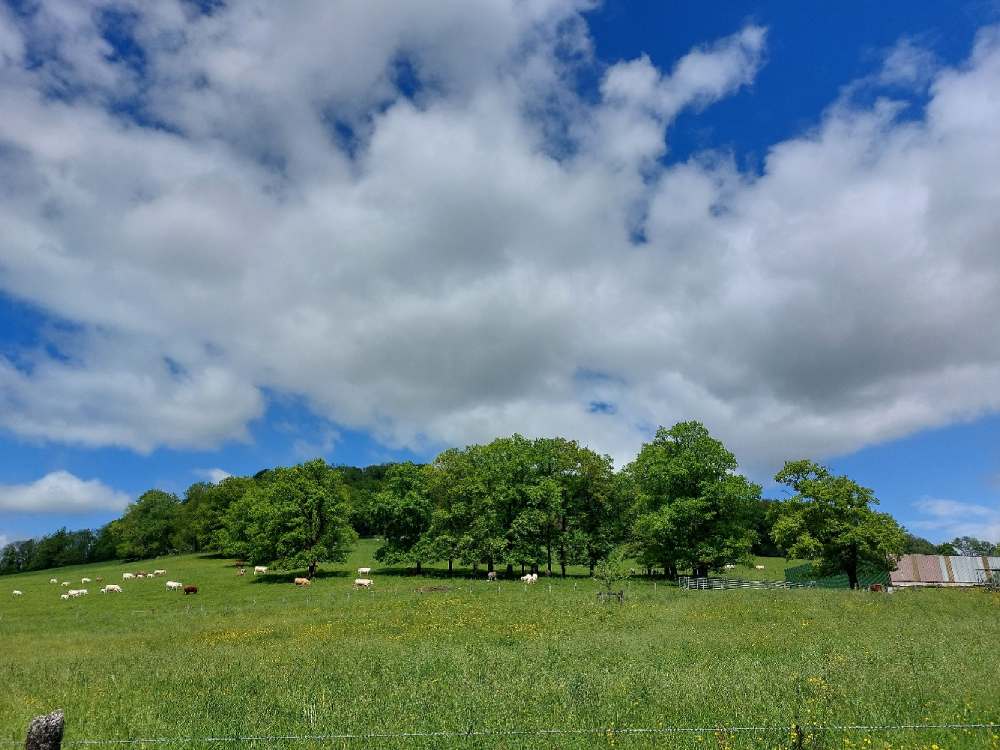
625, 422, 761, 576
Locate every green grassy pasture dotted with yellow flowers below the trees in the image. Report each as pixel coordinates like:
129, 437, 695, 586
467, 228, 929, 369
0, 540, 1000, 749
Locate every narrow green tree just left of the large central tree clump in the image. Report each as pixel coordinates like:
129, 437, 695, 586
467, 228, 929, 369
372, 462, 435, 574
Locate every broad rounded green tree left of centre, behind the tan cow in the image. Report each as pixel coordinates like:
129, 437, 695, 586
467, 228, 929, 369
220, 459, 357, 578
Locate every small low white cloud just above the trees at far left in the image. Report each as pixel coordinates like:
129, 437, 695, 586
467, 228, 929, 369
0, 471, 130, 513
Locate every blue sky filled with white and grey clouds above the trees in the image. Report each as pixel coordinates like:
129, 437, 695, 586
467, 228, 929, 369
0, 0, 1000, 539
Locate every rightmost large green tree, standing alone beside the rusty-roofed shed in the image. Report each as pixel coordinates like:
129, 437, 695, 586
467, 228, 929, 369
772, 460, 906, 588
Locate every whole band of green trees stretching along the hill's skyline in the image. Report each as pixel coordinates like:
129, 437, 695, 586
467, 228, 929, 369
0, 422, 998, 586
